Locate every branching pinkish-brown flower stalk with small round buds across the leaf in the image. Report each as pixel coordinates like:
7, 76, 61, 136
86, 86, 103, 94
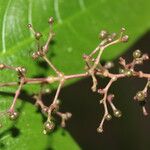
0, 17, 150, 134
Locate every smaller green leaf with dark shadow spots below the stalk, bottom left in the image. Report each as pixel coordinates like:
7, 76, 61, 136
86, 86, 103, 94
0, 103, 80, 150
